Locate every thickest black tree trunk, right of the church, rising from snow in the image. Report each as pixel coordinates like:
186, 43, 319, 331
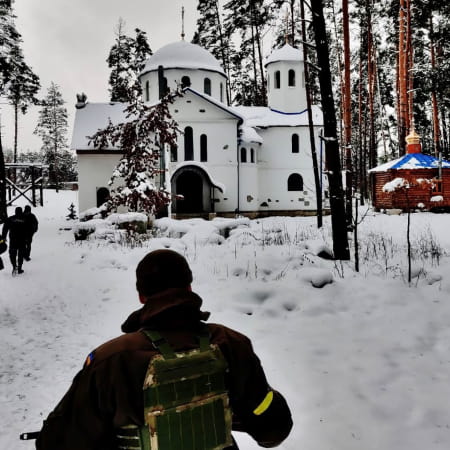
311, 0, 350, 260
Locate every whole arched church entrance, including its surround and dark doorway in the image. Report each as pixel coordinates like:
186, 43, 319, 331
171, 165, 213, 214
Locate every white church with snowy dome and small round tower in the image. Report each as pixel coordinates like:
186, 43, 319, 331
71, 41, 327, 217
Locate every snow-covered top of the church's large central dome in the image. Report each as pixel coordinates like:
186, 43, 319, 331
141, 41, 225, 75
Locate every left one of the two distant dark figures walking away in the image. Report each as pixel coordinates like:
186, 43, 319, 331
2, 206, 26, 275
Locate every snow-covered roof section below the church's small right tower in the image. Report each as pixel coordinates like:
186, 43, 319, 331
233, 105, 323, 128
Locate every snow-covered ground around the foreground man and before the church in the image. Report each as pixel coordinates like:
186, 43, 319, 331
0, 192, 450, 450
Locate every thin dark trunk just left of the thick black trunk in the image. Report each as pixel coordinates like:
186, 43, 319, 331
300, 0, 323, 228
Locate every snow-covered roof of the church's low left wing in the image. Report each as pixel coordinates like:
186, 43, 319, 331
70, 102, 127, 150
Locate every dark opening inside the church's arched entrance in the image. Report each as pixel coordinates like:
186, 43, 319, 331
176, 170, 203, 214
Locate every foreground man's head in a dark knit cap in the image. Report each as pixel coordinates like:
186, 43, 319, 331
136, 249, 192, 303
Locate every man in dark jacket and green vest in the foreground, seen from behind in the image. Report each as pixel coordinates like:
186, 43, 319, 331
36, 249, 292, 450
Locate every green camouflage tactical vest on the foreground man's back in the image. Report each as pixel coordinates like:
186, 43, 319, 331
117, 330, 232, 450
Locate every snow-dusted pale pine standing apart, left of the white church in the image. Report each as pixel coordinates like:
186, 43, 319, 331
34, 82, 68, 192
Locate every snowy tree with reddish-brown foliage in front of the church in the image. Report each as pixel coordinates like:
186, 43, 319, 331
90, 91, 181, 214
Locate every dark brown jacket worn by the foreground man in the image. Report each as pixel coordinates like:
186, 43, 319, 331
36, 289, 292, 450
